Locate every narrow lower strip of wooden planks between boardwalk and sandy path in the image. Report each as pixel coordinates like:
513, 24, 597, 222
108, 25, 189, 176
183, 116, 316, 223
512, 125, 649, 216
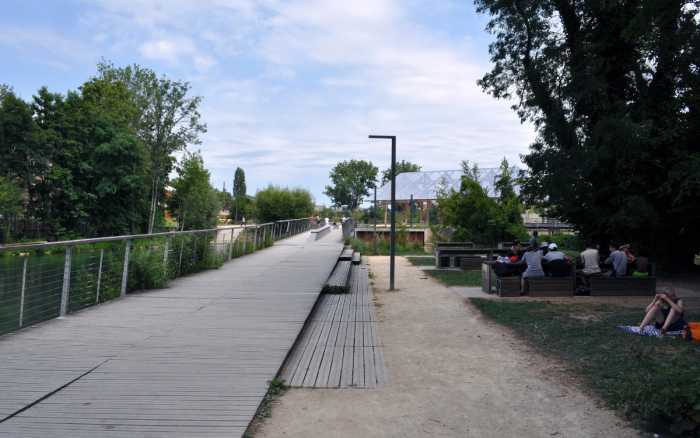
280, 265, 387, 388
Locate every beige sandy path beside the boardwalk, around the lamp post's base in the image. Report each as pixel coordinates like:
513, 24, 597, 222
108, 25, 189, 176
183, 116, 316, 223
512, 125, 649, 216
255, 257, 639, 438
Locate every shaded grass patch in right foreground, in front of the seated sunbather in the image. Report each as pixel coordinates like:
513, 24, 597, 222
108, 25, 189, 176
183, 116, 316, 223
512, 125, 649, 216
471, 298, 700, 436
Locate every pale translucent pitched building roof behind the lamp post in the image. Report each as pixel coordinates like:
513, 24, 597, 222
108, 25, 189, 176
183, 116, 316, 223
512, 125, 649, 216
377, 167, 518, 201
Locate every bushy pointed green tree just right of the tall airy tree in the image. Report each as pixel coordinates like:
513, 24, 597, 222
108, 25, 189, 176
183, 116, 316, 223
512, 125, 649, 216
170, 153, 221, 230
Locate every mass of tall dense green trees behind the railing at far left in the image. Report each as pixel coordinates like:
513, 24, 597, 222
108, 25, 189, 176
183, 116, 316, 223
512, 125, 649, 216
0, 62, 204, 238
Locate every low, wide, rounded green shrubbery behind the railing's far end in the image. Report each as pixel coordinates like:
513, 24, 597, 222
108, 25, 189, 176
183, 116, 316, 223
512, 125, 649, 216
255, 186, 314, 222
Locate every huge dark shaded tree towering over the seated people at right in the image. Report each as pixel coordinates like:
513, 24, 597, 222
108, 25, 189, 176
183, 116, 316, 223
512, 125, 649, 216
475, 0, 700, 266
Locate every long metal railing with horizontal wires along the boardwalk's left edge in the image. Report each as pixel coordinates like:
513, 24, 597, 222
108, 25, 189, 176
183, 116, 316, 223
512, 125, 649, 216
0, 219, 313, 335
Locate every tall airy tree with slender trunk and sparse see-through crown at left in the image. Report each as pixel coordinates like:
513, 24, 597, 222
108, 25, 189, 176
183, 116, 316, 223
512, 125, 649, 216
97, 61, 206, 233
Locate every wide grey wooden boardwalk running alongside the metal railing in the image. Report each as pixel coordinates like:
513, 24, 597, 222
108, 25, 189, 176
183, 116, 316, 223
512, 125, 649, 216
0, 231, 343, 438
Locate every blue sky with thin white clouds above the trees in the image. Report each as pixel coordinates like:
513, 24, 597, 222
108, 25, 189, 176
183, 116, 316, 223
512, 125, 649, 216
0, 0, 535, 204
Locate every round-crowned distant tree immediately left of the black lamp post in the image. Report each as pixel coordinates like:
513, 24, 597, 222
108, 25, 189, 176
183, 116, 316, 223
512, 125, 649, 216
324, 160, 379, 210
